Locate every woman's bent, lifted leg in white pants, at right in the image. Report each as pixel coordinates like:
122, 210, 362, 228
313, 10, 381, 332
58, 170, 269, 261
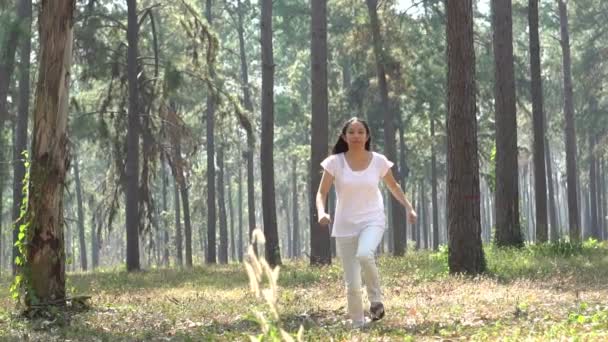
356, 226, 384, 303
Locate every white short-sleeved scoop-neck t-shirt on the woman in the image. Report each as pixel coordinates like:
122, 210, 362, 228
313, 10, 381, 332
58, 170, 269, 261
321, 152, 393, 237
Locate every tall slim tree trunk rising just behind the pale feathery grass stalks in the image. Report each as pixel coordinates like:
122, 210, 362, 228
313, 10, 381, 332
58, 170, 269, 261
260, 0, 282, 267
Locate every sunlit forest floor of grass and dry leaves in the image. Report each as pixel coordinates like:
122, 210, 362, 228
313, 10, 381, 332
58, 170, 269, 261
0, 242, 608, 341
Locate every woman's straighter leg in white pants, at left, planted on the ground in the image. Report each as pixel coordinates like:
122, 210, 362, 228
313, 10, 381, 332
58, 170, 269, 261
336, 236, 364, 322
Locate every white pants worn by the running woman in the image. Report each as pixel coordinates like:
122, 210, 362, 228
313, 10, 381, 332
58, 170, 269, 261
336, 226, 384, 321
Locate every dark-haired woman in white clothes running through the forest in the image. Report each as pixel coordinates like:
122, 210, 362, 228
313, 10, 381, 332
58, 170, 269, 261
316, 117, 417, 328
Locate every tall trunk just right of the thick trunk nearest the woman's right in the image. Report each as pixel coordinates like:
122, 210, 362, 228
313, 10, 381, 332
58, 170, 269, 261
492, 0, 523, 246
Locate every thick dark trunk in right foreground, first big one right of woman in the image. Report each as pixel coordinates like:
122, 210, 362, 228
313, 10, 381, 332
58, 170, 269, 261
447, 0, 485, 274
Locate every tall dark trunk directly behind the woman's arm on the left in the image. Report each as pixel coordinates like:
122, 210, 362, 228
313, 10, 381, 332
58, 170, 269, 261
310, 0, 331, 265
